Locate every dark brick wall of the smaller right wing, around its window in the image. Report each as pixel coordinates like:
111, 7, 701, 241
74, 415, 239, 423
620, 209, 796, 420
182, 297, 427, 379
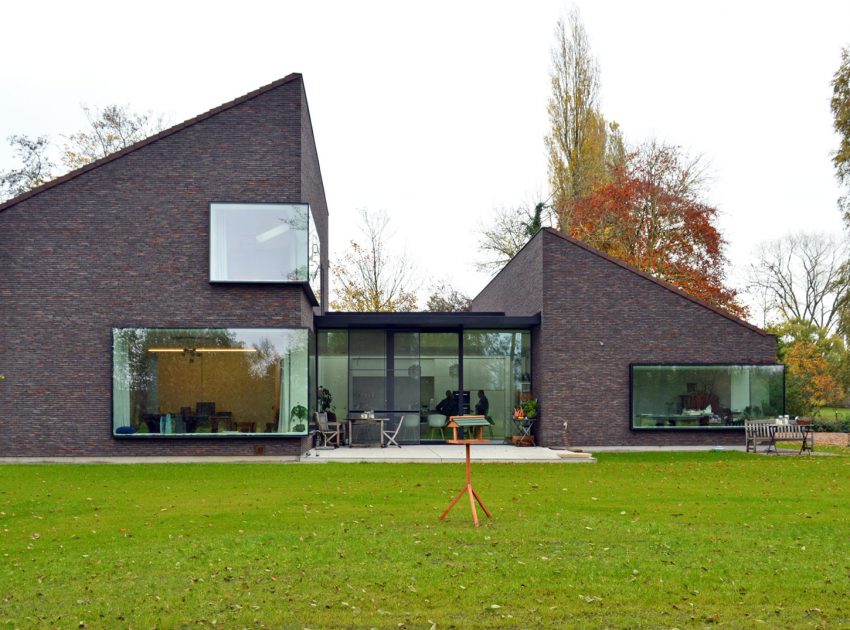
473, 230, 776, 446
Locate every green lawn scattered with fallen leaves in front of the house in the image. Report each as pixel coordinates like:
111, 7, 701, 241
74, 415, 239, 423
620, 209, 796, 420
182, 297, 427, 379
0, 452, 850, 628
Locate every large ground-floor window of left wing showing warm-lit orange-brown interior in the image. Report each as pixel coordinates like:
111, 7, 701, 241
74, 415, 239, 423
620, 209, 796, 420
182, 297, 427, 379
112, 328, 311, 437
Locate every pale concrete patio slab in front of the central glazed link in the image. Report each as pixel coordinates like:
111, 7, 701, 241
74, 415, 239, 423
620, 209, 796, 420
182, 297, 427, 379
301, 444, 596, 464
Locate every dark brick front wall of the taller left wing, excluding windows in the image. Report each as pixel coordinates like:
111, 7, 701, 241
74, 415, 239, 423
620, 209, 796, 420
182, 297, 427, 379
0, 78, 327, 456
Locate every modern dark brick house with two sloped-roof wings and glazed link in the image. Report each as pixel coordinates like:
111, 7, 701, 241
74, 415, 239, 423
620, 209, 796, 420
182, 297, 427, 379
0, 74, 784, 457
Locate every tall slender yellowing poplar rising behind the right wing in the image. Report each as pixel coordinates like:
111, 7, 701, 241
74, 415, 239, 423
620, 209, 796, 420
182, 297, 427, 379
546, 11, 623, 231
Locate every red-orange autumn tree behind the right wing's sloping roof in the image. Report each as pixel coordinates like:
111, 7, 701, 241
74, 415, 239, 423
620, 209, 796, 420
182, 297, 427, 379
569, 140, 746, 316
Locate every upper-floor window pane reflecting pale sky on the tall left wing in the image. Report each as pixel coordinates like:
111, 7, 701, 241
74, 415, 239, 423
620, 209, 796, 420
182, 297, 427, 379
210, 203, 310, 282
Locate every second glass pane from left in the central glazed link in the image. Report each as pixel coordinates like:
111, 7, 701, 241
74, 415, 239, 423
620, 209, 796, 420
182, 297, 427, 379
349, 330, 387, 412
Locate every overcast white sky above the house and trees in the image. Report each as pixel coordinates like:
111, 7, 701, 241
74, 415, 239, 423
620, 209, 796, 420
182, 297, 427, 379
0, 0, 850, 316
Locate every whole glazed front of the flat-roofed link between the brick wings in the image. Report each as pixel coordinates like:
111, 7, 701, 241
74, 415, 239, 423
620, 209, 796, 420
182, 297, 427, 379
317, 329, 532, 442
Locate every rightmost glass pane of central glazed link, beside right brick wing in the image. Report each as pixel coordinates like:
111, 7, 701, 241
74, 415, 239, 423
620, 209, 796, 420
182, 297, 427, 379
463, 330, 534, 437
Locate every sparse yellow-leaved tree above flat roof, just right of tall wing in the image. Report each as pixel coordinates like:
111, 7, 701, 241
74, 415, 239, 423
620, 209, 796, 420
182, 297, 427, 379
331, 210, 416, 312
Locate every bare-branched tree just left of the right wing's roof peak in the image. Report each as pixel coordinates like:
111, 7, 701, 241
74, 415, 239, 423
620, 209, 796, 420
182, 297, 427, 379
477, 201, 553, 273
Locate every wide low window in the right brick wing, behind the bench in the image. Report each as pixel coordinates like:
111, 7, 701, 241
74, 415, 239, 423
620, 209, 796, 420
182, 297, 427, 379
631, 365, 785, 429
